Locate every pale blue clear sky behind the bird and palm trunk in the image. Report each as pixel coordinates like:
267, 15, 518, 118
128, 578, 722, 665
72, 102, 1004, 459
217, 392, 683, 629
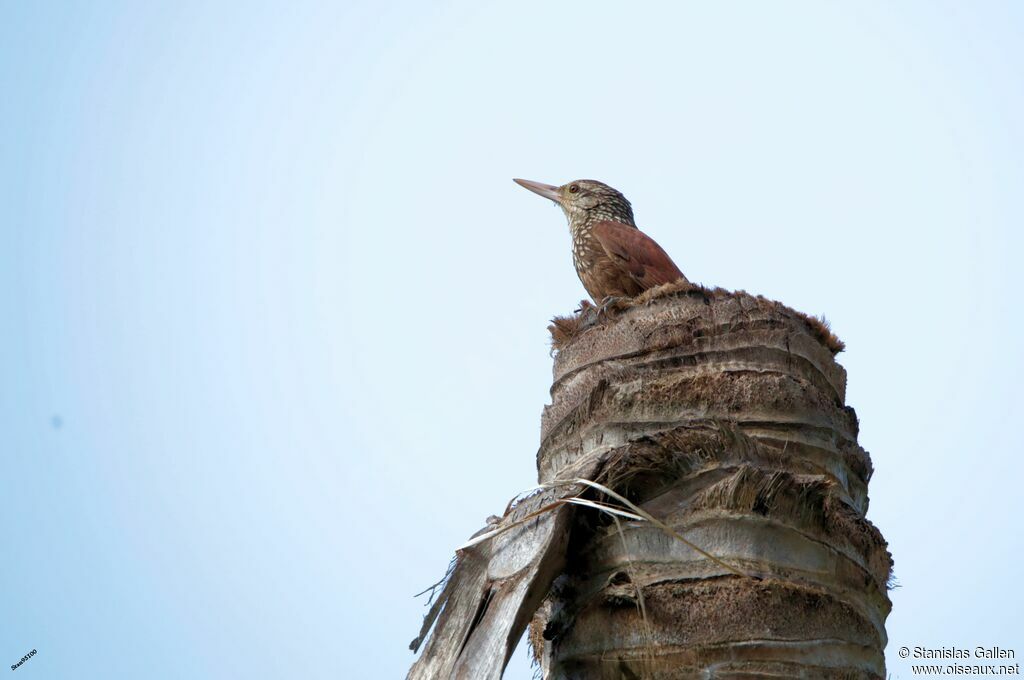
0, 1, 1024, 680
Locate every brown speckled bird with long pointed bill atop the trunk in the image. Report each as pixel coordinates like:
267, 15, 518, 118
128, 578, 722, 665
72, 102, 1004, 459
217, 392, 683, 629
513, 179, 689, 308
